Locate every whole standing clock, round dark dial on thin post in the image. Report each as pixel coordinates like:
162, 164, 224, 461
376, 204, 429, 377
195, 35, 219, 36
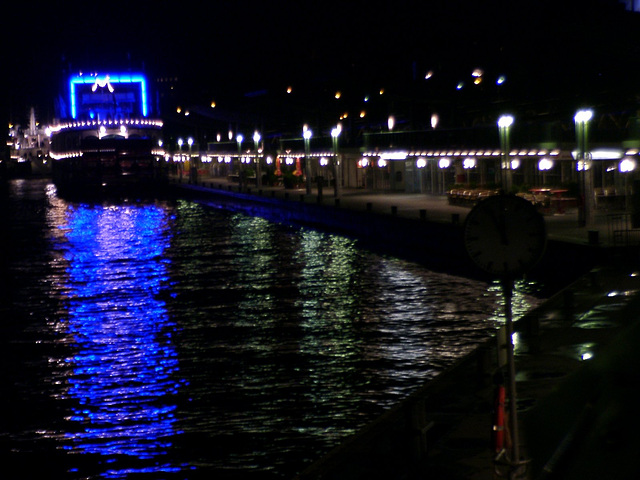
463, 194, 547, 480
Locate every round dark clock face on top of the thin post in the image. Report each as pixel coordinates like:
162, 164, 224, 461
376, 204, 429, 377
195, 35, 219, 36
464, 194, 547, 278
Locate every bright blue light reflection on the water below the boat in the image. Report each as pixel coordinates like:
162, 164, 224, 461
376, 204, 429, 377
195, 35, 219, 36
55, 205, 185, 478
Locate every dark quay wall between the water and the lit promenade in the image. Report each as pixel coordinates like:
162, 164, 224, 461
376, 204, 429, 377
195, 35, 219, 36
171, 184, 615, 295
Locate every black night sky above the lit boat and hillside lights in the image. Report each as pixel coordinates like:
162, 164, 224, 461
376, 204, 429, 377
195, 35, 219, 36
3, 0, 640, 127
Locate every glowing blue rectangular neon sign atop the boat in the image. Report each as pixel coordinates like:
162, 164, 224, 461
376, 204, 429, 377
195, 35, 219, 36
69, 73, 149, 119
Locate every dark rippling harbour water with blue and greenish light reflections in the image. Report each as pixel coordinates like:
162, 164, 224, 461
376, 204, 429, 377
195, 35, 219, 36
0, 180, 535, 479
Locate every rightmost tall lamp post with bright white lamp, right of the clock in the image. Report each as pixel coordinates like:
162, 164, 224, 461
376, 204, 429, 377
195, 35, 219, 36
573, 110, 593, 227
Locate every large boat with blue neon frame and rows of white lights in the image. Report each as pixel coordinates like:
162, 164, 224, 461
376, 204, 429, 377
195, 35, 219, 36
50, 72, 166, 193
